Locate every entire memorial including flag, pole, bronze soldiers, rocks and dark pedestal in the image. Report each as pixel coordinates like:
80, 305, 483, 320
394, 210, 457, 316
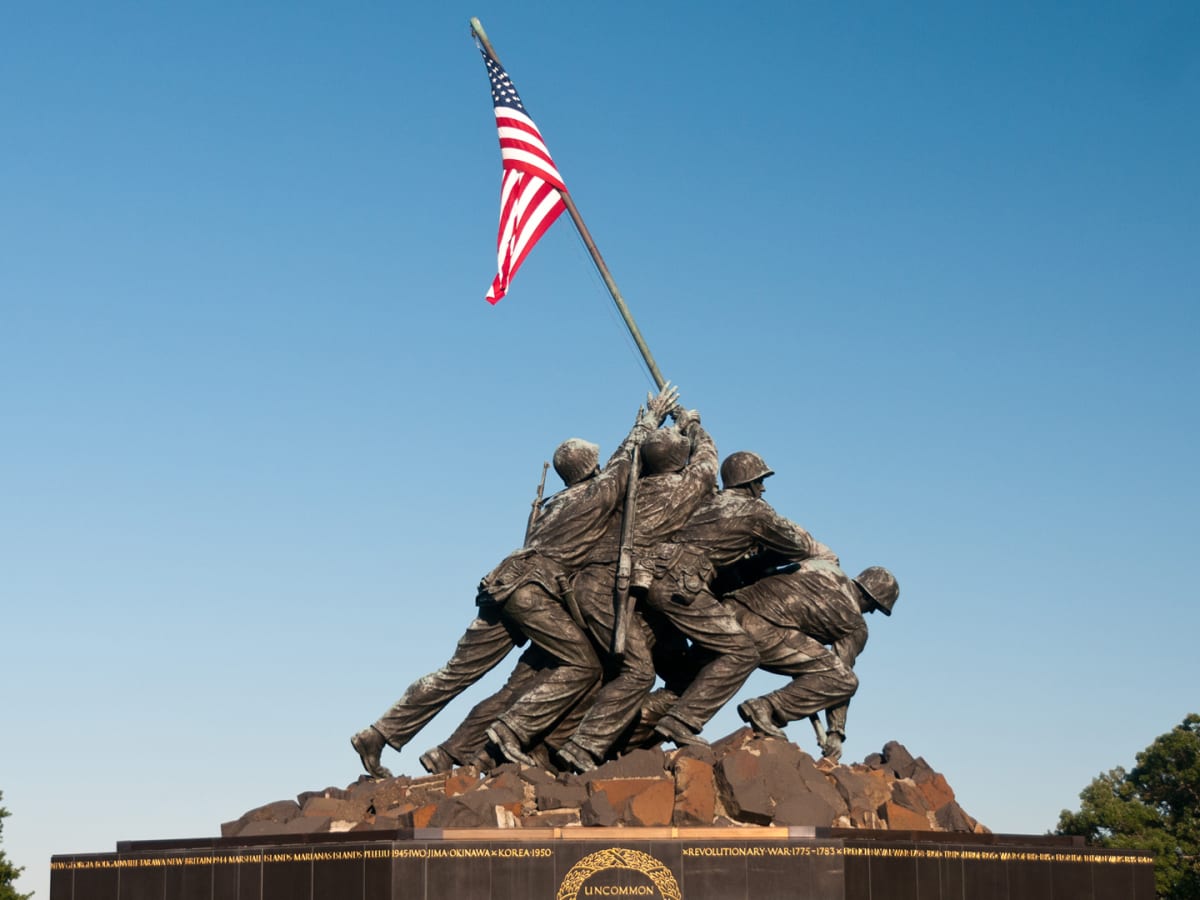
50, 19, 1153, 900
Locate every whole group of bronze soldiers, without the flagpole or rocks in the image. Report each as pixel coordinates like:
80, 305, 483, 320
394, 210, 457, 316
352, 408, 899, 776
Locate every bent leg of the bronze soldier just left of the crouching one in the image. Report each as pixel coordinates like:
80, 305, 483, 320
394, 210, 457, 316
648, 586, 758, 743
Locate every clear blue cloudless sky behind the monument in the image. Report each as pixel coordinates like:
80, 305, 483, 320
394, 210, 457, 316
0, 0, 1200, 898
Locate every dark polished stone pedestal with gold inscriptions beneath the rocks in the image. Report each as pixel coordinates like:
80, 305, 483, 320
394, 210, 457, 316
50, 827, 1154, 900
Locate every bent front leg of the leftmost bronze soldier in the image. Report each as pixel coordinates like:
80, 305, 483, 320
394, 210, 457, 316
489, 583, 601, 746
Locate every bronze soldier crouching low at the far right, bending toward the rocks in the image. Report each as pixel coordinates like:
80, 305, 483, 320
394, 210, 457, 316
728, 559, 900, 761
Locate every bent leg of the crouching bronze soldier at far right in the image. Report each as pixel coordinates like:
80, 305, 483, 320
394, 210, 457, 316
737, 606, 858, 725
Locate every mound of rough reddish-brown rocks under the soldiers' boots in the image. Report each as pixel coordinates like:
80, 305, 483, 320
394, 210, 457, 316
221, 728, 988, 838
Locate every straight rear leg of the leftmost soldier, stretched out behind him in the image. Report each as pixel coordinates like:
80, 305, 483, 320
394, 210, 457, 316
364, 607, 515, 750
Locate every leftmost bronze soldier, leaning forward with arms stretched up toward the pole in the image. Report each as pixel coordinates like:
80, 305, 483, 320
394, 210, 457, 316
350, 386, 678, 778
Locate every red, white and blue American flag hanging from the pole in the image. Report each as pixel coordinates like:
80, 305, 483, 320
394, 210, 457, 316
480, 48, 566, 304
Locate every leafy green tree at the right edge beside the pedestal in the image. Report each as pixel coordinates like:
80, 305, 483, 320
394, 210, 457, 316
1057, 713, 1200, 900
